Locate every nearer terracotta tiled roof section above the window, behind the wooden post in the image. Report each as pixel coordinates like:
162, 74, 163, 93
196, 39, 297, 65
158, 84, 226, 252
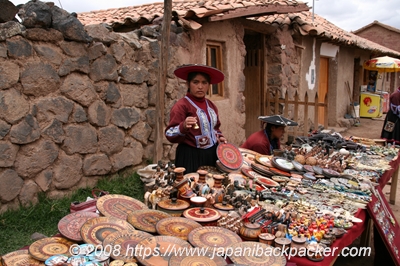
78, 0, 309, 28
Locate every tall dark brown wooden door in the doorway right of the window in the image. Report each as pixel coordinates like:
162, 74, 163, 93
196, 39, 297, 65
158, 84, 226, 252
243, 34, 264, 138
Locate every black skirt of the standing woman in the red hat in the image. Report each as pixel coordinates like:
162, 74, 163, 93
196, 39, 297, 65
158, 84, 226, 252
175, 143, 218, 174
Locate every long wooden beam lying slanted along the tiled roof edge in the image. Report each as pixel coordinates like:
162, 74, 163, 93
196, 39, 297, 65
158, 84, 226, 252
208, 4, 310, 21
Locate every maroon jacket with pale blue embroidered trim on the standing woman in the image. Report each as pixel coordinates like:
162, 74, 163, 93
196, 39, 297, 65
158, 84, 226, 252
165, 93, 222, 149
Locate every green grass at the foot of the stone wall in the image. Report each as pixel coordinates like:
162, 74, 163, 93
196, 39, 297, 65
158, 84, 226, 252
0, 172, 144, 255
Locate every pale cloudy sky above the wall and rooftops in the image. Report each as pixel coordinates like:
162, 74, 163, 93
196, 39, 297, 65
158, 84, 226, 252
10, 0, 400, 31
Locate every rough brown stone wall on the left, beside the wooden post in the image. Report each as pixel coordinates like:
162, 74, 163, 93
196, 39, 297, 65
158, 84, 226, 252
0, 1, 187, 213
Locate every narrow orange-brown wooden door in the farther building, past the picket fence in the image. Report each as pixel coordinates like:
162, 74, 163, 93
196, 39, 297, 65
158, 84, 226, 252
318, 57, 329, 125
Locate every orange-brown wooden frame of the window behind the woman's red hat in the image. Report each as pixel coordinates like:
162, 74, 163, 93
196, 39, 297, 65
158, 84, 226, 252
206, 41, 224, 100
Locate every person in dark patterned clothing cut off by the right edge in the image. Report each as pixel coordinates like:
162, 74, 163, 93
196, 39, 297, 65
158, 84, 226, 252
381, 87, 400, 144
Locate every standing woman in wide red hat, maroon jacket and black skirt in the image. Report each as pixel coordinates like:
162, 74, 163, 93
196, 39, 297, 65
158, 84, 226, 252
165, 65, 226, 173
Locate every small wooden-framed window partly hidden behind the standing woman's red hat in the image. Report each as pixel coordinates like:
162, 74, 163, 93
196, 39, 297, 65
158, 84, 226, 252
207, 42, 224, 97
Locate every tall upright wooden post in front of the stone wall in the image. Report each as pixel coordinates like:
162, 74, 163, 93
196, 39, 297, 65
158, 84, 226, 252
153, 0, 172, 163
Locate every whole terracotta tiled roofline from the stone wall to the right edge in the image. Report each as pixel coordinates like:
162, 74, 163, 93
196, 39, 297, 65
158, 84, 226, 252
78, 0, 400, 57
